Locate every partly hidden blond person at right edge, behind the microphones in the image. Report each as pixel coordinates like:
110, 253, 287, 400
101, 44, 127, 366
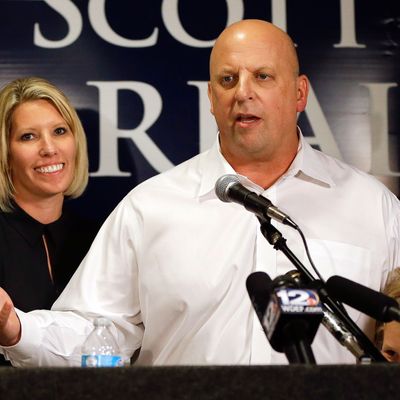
376, 268, 400, 363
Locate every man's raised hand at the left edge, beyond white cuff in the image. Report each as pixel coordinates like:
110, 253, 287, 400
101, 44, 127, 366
0, 288, 21, 346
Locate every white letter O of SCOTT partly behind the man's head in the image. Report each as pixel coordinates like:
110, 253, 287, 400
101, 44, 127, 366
161, 0, 244, 47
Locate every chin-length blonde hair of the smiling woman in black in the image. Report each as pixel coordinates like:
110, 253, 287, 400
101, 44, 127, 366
0, 77, 89, 211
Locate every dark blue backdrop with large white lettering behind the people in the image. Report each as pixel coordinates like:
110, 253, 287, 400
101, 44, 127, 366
0, 0, 400, 219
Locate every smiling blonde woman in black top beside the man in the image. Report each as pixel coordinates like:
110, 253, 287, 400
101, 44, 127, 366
0, 77, 97, 311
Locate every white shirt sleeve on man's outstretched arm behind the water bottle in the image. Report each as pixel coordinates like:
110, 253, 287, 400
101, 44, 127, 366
3, 198, 143, 366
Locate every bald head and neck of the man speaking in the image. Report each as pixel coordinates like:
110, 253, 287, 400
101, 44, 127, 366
209, 20, 308, 188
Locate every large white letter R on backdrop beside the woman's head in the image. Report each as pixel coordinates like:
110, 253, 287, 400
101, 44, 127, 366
87, 81, 173, 176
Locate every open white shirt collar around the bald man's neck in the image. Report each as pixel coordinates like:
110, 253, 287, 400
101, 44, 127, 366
197, 127, 335, 200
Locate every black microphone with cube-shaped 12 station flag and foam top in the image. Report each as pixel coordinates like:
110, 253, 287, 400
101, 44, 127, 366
246, 272, 322, 364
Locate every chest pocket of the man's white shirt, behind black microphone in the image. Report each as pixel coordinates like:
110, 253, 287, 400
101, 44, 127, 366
307, 239, 371, 322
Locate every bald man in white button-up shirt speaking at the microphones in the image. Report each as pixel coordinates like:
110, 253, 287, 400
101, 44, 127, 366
0, 20, 400, 366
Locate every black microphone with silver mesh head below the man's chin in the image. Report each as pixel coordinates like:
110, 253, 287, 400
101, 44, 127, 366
215, 174, 297, 229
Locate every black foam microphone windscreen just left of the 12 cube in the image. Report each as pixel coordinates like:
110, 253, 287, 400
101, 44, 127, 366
246, 271, 273, 319
